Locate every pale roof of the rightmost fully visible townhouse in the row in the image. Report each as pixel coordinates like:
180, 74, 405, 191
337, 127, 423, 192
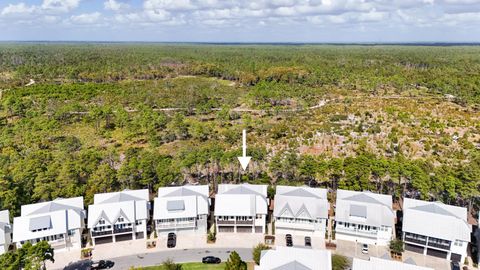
402, 198, 472, 242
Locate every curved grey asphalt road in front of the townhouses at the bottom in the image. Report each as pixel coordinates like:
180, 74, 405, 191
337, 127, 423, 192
111, 248, 253, 270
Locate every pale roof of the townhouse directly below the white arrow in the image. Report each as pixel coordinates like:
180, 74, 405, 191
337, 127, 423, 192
215, 184, 268, 216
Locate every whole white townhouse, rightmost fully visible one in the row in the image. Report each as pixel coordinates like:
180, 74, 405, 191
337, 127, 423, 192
402, 199, 472, 263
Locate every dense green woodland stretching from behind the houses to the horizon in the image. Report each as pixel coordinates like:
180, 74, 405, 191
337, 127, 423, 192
0, 43, 480, 215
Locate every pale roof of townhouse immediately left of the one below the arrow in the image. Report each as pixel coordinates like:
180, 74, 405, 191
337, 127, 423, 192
153, 185, 210, 220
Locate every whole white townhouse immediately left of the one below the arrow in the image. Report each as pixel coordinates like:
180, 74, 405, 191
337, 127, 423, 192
153, 185, 210, 235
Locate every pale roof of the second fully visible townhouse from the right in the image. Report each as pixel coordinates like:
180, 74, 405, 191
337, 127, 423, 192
335, 189, 395, 227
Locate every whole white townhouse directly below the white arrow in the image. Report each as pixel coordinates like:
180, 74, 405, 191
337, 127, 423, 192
215, 184, 268, 233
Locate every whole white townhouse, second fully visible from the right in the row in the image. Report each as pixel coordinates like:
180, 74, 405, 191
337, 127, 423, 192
335, 189, 395, 245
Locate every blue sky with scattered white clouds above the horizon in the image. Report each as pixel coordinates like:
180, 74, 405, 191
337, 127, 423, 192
0, 0, 480, 43
